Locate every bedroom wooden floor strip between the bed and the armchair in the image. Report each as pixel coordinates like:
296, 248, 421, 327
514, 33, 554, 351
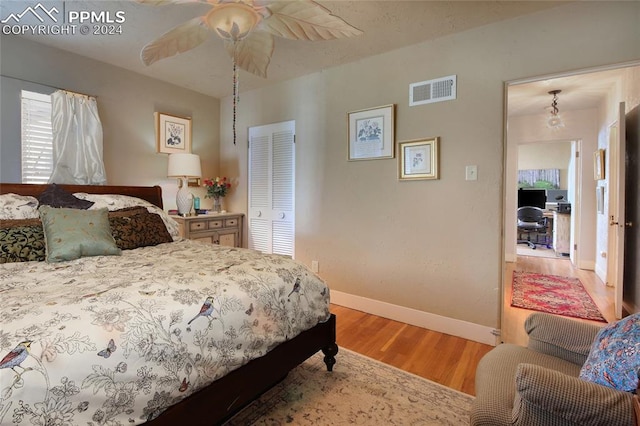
331, 305, 493, 395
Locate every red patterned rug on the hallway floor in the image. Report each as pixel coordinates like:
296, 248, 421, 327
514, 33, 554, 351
511, 271, 607, 322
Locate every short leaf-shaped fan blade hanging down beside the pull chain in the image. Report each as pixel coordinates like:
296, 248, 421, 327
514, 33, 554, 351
224, 30, 274, 78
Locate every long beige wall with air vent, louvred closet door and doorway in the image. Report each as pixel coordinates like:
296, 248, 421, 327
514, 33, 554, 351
220, 2, 640, 327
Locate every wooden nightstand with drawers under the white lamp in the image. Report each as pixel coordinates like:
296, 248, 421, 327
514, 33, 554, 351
171, 213, 244, 247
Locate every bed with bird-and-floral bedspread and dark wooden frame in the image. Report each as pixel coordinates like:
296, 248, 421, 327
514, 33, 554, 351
0, 184, 338, 426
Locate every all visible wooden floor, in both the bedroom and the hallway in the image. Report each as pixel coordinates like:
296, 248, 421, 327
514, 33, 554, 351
331, 256, 614, 395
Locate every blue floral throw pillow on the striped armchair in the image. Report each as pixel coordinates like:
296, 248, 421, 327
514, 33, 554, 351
580, 313, 640, 392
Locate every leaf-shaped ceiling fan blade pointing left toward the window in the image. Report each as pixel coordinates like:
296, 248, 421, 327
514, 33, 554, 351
140, 16, 209, 65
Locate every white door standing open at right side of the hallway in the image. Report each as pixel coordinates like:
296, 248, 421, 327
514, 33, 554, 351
605, 102, 626, 319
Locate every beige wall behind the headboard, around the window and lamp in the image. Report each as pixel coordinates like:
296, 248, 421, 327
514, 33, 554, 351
1, 36, 220, 208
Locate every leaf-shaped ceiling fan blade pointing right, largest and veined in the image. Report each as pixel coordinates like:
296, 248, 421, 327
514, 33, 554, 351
263, 0, 362, 41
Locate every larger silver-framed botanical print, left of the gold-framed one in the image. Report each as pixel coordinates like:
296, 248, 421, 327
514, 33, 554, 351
348, 104, 395, 161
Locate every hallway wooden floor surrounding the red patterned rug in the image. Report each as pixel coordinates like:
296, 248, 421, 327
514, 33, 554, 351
502, 256, 615, 345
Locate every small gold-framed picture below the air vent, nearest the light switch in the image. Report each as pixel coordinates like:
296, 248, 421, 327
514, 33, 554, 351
398, 137, 440, 180
